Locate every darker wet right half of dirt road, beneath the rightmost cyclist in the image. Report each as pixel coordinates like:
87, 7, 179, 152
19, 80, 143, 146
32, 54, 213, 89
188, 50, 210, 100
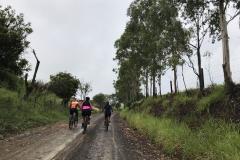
54, 114, 170, 160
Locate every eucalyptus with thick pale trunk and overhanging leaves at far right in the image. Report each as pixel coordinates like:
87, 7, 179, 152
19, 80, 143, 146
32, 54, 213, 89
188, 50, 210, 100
178, 0, 240, 88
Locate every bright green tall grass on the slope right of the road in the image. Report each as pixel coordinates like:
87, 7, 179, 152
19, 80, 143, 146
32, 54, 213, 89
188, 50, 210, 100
120, 110, 240, 160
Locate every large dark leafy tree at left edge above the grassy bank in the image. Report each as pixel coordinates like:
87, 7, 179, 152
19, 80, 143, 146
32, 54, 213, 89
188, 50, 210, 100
0, 6, 33, 76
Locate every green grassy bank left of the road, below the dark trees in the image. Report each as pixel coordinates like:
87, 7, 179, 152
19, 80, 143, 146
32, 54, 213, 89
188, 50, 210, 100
0, 88, 67, 135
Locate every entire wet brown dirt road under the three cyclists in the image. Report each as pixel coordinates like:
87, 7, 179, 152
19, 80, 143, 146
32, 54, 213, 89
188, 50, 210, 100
0, 114, 170, 160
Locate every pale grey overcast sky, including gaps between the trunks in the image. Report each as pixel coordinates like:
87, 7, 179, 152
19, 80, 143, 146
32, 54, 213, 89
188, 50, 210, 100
0, 0, 240, 96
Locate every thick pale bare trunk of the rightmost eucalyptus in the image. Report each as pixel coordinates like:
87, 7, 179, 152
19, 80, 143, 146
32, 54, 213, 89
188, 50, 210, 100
219, 0, 233, 88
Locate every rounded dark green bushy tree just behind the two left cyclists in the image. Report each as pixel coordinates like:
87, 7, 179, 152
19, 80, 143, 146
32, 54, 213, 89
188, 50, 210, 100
49, 72, 80, 105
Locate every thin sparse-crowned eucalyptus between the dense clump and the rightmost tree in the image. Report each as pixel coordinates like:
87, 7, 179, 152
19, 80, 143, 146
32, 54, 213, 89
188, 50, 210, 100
178, 0, 211, 91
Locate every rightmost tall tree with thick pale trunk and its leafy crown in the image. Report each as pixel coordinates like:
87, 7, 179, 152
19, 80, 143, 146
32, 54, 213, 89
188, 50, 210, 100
182, 0, 240, 89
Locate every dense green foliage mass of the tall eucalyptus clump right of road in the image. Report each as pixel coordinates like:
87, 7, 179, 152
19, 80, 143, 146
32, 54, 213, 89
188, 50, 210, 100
115, 0, 189, 99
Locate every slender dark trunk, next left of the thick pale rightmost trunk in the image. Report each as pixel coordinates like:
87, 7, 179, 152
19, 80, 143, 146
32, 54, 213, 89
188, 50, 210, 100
197, 20, 204, 92
